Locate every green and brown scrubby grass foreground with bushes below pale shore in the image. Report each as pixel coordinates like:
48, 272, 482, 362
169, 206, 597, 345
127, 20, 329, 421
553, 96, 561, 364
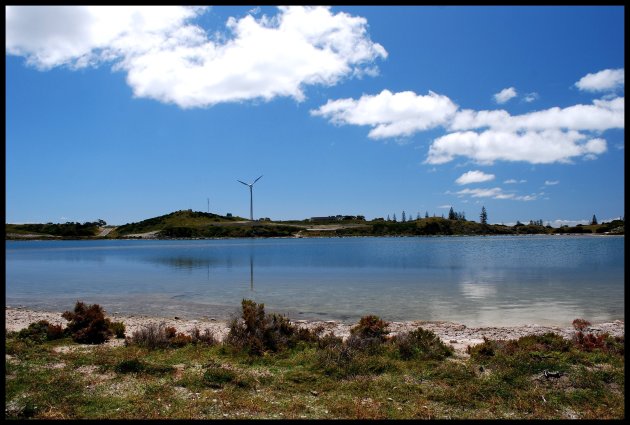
5, 300, 625, 419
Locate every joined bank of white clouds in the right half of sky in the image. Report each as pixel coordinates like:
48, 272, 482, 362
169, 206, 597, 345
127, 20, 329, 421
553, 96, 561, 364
311, 83, 625, 164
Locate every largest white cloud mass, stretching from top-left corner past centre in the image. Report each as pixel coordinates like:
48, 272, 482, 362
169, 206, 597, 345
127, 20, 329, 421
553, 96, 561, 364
6, 6, 387, 108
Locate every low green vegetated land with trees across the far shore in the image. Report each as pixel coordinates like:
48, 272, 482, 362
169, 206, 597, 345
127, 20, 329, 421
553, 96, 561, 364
5, 207, 625, 239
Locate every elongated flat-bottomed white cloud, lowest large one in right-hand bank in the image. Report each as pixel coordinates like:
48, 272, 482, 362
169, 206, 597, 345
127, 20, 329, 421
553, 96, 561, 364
425, 130, 606, 165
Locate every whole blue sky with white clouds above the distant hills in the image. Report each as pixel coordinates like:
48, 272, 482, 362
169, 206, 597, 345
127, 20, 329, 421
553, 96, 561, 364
6, 6, 625, 226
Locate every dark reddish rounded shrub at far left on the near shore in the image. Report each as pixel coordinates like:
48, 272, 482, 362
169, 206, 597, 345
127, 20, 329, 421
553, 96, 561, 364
62, 301, 112, 344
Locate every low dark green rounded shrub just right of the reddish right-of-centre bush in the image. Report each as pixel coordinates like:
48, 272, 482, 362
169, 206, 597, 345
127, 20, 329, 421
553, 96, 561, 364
393, 328, 453, 360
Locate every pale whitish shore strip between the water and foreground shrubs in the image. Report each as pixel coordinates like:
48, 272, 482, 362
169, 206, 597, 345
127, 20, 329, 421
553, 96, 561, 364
5, 307, 624, 355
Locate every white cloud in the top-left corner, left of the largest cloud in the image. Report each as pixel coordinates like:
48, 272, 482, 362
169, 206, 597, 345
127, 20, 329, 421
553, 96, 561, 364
6, 6, 204, 70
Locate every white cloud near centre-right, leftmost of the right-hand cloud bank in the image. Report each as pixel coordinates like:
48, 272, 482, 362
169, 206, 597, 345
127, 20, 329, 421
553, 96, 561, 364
311, 90, 457, 139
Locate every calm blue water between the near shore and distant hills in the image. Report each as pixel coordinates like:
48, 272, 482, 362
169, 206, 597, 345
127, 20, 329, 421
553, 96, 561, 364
5, 236, 624, 326
